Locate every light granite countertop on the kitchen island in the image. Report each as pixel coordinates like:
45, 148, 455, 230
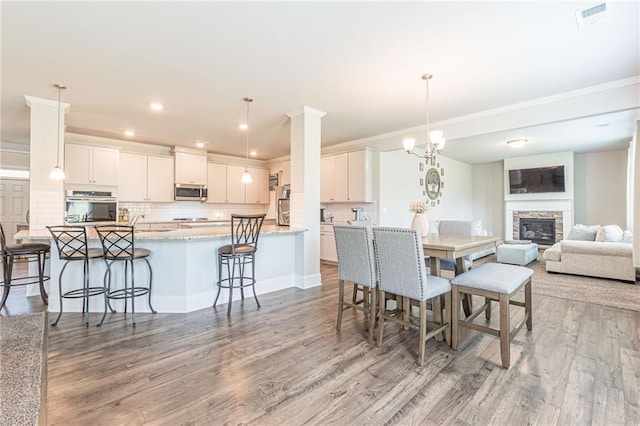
15, 225, 307, 241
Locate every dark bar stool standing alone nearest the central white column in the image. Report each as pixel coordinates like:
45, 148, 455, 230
213, 214, 266, 316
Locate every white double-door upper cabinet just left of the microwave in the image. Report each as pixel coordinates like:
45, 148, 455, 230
118, 152, 174, 202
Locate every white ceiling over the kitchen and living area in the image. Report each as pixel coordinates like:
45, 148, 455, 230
0, 1, 640, 164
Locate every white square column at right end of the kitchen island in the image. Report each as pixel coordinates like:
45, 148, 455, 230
287, 106, 326, 288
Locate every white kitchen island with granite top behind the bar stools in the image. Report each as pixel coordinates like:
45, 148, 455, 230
16, 225, 306, 313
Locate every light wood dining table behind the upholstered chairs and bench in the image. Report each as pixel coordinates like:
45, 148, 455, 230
422, 233, 500, 316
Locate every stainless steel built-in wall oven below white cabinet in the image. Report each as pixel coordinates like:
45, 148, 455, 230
64, 190, 118, 224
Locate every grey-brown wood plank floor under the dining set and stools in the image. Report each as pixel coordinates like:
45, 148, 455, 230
0, 265, 640, 425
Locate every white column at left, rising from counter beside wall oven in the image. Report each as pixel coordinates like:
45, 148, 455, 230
24, 95, 69, 229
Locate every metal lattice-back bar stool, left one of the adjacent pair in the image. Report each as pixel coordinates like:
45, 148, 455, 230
47, 225, 107, 327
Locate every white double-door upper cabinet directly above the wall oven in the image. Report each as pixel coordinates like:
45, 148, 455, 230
64, 144, 119, 186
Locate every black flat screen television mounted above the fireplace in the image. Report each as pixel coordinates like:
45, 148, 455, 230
509, 166, 565, 194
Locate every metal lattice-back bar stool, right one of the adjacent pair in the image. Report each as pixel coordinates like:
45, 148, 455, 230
95, 225, 157, 327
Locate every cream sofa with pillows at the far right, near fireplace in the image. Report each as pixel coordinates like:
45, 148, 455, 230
542, 225, 636, 282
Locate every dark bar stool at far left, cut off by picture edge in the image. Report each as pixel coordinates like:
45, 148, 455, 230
0, 224, 50, 309
